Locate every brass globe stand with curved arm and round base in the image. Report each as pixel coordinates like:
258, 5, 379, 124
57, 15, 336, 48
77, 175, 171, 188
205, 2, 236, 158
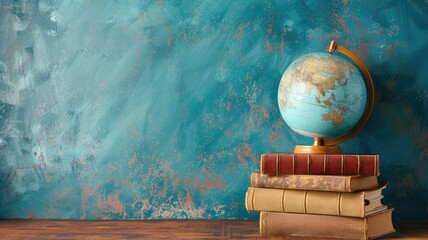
294, 41, 374, 154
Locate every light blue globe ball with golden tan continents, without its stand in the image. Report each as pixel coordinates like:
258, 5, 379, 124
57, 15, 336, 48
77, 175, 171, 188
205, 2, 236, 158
278, 52, 367, 138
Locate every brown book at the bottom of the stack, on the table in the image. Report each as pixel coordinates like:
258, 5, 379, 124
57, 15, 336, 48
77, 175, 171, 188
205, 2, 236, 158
260, 209, 395, 239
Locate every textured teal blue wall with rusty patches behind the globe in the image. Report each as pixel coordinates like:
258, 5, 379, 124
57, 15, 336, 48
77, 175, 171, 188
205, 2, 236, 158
0, 0, 428, 220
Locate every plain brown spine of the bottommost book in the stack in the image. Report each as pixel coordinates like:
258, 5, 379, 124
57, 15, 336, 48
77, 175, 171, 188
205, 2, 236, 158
259, 212, 367, 239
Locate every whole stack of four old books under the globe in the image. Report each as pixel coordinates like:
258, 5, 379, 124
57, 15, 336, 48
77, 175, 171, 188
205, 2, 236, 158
245, 153, 395, 239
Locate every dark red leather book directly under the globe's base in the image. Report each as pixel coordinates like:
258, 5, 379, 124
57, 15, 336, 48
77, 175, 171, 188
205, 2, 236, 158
260, 153, 379, 176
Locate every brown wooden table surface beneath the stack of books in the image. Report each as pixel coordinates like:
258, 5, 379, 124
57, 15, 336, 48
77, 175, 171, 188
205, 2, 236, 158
0, 220, 428, 240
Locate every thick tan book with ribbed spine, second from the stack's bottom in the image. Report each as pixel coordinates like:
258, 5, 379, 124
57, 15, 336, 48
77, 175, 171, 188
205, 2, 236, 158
245, 185, 386, 218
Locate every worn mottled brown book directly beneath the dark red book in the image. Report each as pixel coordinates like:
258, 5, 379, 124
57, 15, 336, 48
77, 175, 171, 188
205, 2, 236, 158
251, 172, 378, 192
